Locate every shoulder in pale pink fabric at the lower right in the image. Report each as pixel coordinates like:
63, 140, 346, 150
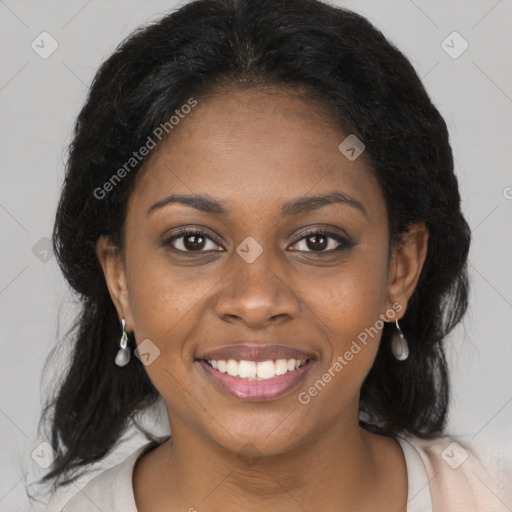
400, 435, 512, 512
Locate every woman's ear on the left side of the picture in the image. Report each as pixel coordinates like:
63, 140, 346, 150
96, 235, 133, 332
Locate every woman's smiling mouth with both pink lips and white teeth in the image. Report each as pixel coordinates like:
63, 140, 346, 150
195, 346, 315, 400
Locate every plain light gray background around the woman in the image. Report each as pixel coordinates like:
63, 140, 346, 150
0, 0, 512, 511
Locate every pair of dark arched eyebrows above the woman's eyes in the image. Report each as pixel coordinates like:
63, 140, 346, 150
147, 191, 367, 217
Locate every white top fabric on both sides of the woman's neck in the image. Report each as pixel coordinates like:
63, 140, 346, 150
61, 437, 432, 512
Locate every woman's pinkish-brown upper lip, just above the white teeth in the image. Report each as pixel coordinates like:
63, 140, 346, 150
196, 342, 315, 362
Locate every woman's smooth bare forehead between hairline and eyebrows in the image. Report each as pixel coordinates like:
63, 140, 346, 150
129, 89, 383, 222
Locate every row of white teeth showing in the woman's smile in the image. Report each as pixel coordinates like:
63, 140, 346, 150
208, 359, 306, 380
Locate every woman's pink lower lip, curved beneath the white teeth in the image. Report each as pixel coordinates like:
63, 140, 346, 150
197, 359, 313, 400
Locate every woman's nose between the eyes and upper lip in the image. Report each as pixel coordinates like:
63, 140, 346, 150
215, 246, 299, 329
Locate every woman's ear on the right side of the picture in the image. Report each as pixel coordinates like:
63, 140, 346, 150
388, 222, 428, 320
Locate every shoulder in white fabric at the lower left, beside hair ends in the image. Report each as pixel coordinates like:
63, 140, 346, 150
60, 441, 156, 512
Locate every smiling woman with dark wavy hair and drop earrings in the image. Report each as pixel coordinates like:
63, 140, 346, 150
34, 0, 510, 512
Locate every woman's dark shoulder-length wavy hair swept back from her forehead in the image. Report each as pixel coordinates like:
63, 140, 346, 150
34, 0, 470, 496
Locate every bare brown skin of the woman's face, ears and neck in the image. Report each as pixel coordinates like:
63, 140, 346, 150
97, 89, 428, 512
